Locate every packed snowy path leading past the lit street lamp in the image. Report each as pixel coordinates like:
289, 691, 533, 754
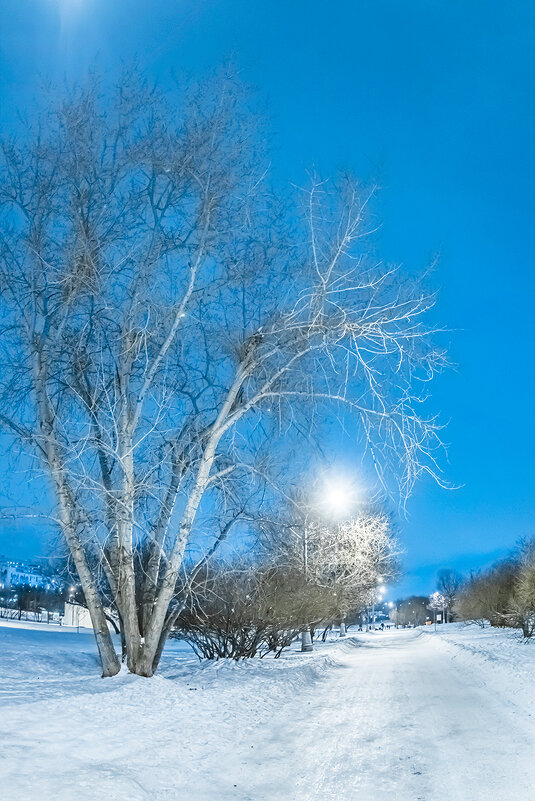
272, 631, 535, 801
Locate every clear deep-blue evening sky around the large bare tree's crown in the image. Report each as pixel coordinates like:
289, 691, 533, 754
0, 0, 535, 593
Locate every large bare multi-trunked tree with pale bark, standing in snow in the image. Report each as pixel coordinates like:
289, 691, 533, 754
0, 74, 444, 676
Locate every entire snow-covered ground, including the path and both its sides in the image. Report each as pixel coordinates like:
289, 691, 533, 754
0, 624, 535, 801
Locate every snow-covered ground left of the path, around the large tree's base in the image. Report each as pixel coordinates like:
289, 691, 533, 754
0, 626, 355, 801
